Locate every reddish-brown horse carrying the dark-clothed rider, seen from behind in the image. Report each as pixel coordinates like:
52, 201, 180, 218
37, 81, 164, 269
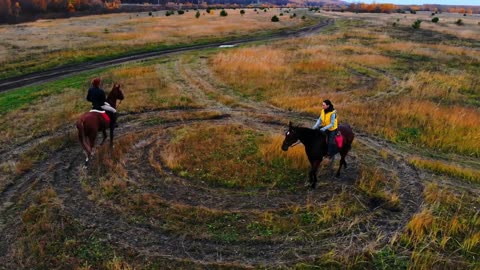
76, 84, 124, 164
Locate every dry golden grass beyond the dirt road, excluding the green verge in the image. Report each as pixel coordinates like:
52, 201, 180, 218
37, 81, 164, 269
0, 9, 302, 67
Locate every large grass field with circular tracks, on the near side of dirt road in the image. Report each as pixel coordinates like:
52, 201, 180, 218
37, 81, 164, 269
0, 10, 480, 269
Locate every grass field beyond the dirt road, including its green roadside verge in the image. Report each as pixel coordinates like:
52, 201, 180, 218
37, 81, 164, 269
0, 9, 309, 78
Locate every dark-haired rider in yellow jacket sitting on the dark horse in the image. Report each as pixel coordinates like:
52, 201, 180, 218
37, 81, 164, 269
313, 99, 338, 158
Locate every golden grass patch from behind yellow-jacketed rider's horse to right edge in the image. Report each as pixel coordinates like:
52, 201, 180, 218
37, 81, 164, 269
343, 97, 480, 156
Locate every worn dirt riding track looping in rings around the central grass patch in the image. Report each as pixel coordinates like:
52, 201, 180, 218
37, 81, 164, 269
0, 49, 432, 268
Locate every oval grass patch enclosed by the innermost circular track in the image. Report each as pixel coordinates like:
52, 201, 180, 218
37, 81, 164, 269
161, 124, 305, 188
